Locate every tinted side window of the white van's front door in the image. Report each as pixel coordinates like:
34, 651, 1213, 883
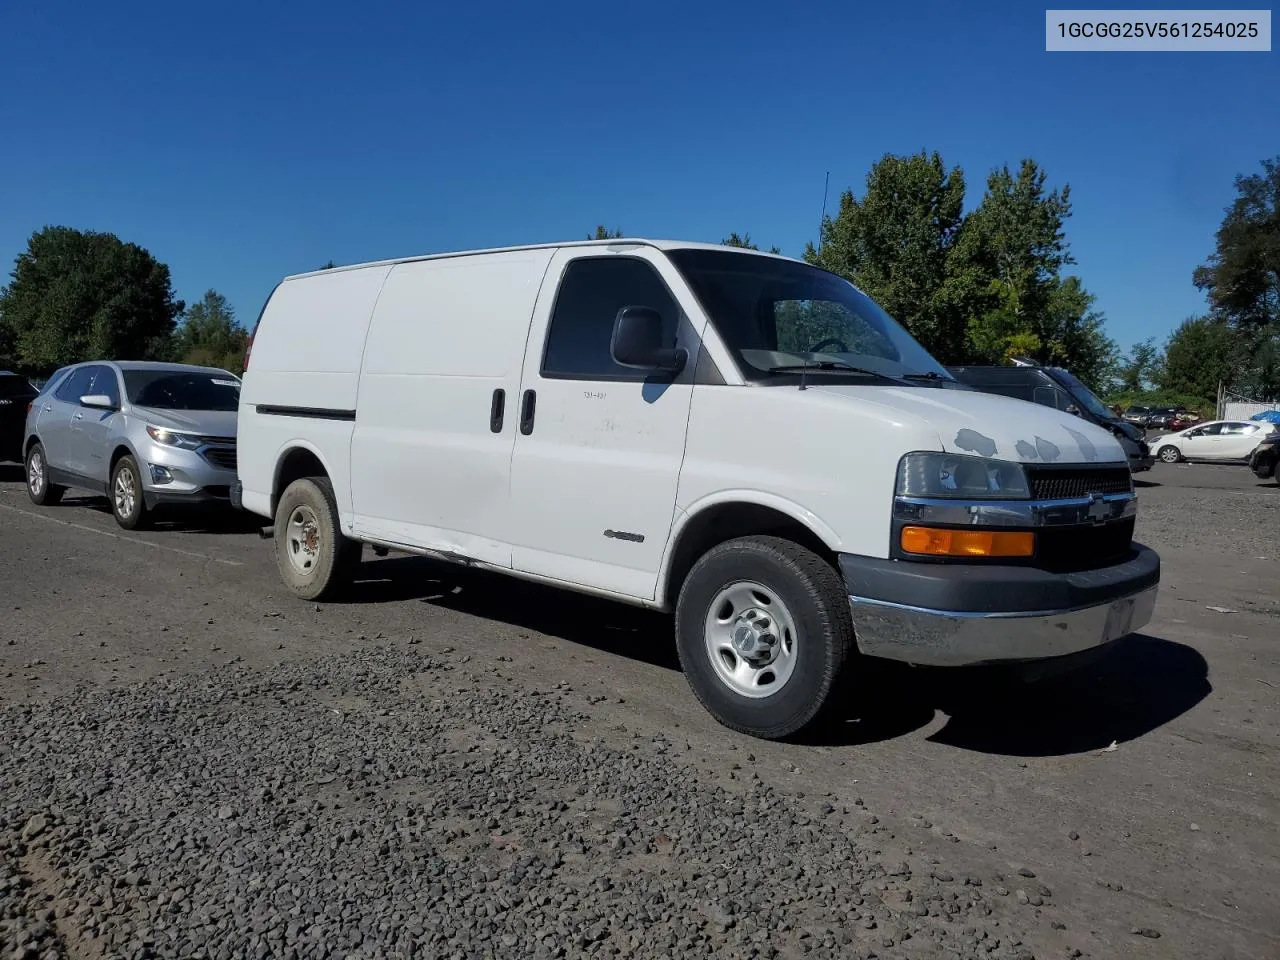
541, 256, 680, 380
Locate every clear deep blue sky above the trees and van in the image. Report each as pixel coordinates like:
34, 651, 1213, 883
0, 0, 1280, 358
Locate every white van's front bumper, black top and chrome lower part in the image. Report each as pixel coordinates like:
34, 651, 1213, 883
840, 544, 1160, 667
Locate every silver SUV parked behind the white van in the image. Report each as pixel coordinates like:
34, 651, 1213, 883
23, 361, 241, 530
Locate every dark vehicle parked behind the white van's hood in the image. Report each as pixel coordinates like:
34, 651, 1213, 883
947, 366, 1155, 474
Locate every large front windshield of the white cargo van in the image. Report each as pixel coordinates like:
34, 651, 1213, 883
668, 250, 954, 384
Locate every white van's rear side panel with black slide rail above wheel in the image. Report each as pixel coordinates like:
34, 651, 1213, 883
237, 266, 390, 532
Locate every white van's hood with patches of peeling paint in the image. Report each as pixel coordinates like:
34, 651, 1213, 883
809, 384, 1128, 463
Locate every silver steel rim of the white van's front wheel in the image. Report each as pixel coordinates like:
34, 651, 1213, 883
703, 580, 799, 700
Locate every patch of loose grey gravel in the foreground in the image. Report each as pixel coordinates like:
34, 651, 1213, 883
0, 649, 1052, 957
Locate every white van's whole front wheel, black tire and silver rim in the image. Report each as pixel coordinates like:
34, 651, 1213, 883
676, 536, 854, 740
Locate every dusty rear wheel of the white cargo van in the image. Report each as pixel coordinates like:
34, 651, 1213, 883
274, 476, 364, 600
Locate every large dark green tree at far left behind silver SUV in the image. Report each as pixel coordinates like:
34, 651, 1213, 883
0, 227, 183, 372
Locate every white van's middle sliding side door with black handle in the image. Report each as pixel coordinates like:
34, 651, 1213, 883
351, 250, 554, 566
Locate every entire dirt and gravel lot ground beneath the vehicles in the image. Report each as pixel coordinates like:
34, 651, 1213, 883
0, 465, 1280, 960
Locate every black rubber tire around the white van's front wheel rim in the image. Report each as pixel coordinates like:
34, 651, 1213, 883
676, 536, 855, 740
